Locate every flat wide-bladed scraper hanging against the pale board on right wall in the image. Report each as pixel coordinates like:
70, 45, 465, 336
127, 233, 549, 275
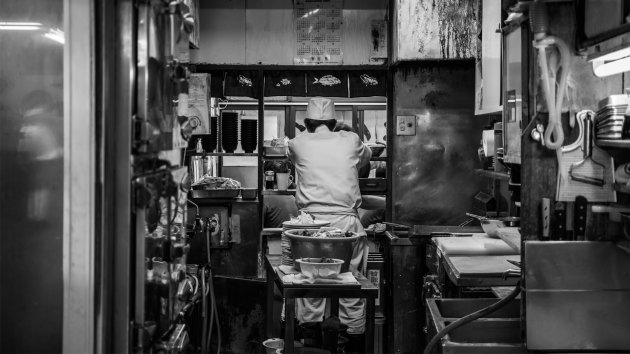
569, 114, 606, 186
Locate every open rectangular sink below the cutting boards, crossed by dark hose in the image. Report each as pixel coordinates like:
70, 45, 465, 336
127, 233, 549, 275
427, 299, 526, 354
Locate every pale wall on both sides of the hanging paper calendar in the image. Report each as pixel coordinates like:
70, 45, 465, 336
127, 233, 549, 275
191, 0, 387, 65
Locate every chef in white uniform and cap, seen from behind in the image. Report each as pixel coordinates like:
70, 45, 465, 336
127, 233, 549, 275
289, 97, 372, 334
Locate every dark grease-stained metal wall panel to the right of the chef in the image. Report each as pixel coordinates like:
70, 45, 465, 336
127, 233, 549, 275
388, 60, 488, 225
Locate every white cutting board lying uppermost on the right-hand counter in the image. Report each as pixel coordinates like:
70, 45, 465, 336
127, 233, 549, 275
435, 233, 519, 256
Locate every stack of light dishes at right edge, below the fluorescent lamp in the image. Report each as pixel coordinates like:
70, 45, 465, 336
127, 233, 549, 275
595, 95, 628, 139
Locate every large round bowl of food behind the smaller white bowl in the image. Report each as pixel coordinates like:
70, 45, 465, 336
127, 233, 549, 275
284, 229, 360, 273
